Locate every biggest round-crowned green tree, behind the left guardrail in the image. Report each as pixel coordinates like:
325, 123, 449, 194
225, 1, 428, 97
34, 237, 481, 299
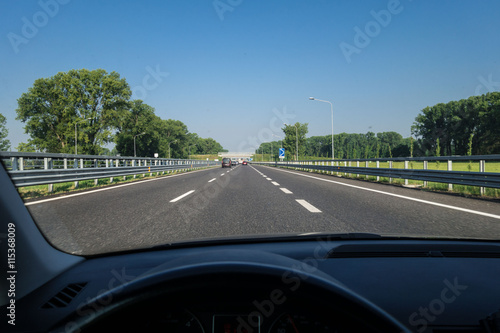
16, 69, 131, 154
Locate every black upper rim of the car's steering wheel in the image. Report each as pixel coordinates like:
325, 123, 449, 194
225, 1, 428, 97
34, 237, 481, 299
50, 250, 410, 333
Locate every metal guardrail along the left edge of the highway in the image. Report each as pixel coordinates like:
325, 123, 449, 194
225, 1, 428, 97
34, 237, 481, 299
0, 152, 220, 187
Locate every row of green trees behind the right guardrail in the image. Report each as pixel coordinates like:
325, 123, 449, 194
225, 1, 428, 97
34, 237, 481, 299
255, 92, 500, 159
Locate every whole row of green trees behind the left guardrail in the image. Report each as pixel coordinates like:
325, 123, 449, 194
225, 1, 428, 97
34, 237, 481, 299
11, 69, 224, 158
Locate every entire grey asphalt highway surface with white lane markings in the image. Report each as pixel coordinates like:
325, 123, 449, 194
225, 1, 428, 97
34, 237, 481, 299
27, 165, 500, 254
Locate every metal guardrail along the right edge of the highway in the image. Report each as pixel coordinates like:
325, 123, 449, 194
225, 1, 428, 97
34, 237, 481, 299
252, 155, 500, 189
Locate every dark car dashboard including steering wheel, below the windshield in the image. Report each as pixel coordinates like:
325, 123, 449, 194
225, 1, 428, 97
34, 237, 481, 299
3, 236, 500, 333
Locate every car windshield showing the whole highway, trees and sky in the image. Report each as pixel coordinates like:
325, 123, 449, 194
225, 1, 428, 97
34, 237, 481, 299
0, 0, 500, 255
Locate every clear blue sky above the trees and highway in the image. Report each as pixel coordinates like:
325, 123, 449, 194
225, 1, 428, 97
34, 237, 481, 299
0, 0, 500, 151
